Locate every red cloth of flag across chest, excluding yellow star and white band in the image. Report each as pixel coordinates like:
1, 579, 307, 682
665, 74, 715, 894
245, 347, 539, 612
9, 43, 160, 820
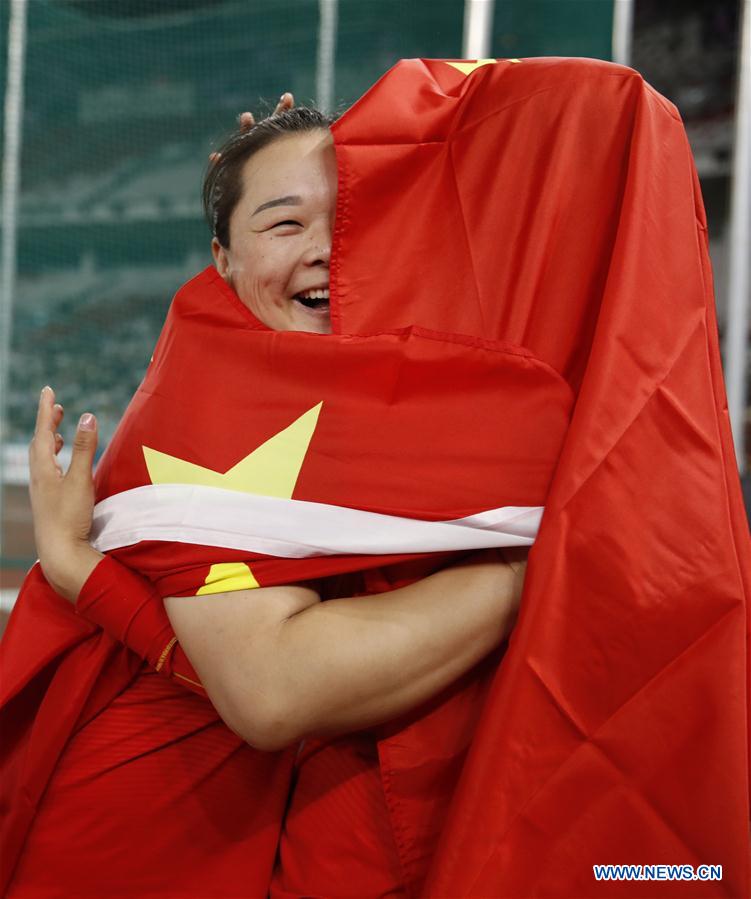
96, 278, 573, 596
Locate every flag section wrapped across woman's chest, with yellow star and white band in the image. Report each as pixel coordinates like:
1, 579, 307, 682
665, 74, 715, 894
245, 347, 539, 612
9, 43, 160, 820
88, 268, 572, 596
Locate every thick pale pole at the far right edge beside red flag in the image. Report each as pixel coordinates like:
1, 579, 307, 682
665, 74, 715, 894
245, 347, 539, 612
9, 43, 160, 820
724, 0, 751, 474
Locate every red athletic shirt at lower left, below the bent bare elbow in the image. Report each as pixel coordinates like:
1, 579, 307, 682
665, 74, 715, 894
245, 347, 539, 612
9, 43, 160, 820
7, 668, 294, 899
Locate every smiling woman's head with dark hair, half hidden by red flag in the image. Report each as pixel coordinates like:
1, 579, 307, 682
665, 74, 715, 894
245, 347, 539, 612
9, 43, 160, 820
203, 107, 337, 334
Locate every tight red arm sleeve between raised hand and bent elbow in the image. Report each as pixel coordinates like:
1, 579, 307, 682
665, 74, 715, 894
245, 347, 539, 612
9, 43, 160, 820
76, 556, 206, 696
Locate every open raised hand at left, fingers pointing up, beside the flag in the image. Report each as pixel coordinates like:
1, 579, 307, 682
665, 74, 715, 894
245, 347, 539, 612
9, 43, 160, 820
29, 387, 103, 601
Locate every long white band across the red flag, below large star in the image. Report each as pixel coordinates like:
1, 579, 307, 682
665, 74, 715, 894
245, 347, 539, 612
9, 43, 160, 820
92, 484, 543, 559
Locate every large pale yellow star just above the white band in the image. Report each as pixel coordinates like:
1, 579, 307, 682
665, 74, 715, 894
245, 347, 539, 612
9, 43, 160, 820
143, 402, 323, 499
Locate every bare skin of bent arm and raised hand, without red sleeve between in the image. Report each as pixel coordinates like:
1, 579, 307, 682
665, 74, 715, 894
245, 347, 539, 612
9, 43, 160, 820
29, 388, 523, 750
